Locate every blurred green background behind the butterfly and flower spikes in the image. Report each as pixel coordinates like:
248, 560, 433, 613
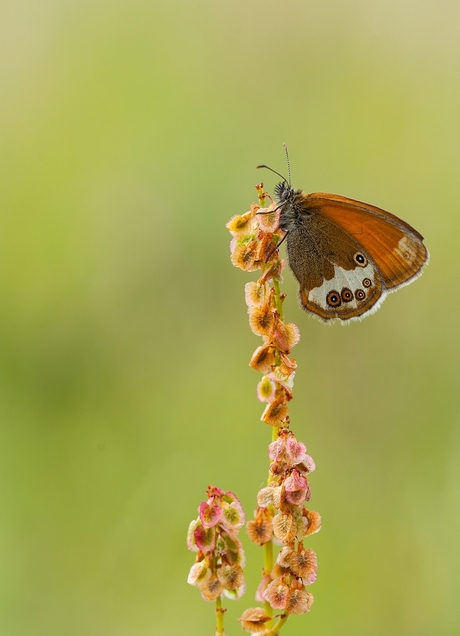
0, 0, 460, 636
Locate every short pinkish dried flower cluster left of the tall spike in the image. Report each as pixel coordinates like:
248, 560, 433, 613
187, 486, 246, 601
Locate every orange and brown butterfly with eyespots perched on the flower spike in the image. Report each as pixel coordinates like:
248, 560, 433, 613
257, 147, 429, 323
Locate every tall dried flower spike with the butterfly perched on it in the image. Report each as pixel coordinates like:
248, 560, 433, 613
227, 184, 321, 634
